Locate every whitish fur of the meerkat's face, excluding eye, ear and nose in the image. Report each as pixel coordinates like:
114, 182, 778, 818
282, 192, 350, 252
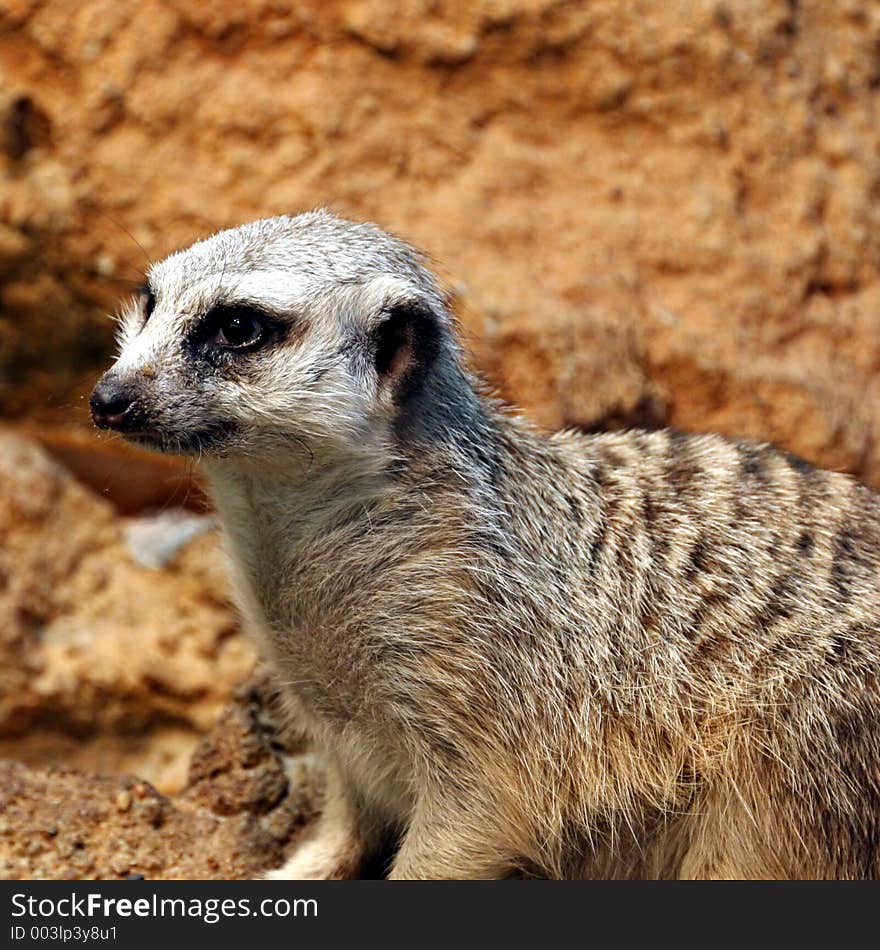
103, 212, 445, 455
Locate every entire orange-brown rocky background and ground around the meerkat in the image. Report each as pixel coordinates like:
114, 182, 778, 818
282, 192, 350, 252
0, 0, 880, 877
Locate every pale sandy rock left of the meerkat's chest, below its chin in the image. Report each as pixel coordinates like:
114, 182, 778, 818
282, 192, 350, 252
0, 432, 254, 791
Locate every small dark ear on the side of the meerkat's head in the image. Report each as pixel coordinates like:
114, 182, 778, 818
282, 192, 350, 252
373, 300, 441, 402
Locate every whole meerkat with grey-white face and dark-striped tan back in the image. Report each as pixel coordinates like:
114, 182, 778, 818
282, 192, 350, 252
91, 211, 880, 879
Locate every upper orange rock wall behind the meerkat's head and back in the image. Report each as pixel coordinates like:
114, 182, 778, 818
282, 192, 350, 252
0, 0, 880, 483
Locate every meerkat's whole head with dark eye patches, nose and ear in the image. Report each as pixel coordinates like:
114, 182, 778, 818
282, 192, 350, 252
90, 211, 468, 468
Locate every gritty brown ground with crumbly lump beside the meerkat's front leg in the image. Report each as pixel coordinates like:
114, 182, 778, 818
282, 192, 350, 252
0, 688, 322, 880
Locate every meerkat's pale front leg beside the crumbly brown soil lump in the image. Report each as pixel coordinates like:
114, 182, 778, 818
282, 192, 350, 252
263, 764, 371, 881
